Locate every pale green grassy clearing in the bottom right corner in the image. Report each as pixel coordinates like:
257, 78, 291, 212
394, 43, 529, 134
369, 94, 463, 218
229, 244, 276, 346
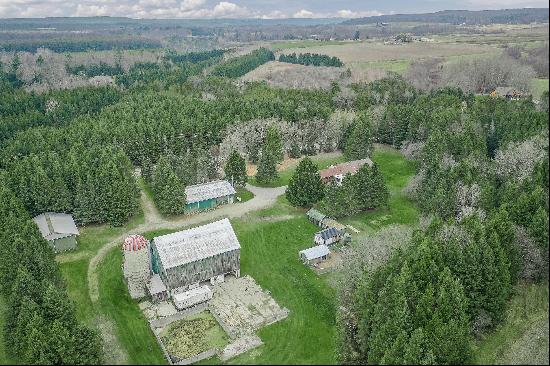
473, 283, 548, 365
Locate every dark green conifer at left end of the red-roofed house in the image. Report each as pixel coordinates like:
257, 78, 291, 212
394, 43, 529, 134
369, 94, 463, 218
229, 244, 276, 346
286, 157, 325, 207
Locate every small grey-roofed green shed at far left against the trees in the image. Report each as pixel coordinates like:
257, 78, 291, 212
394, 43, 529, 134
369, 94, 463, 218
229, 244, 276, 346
33, 212, 79, 252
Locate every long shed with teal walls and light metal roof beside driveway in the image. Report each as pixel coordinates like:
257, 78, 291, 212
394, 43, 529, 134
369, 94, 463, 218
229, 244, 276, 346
185, 180, 237, 213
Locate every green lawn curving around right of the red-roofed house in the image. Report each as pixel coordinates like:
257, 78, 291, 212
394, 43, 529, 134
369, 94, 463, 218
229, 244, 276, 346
339, 146, 418, 233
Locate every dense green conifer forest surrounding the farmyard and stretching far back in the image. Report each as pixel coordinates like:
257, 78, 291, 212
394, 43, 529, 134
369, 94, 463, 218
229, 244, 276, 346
0, 33, 549, 364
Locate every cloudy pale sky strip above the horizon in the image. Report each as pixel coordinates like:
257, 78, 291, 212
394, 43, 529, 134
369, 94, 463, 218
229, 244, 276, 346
0, 0, 548, 19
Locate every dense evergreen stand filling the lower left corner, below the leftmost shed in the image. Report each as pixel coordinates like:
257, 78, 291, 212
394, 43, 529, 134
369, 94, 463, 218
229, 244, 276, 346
0, 182, 103, 365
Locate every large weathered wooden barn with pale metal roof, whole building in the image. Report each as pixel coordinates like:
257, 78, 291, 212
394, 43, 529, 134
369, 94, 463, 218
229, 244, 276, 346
151, 218, 241, 292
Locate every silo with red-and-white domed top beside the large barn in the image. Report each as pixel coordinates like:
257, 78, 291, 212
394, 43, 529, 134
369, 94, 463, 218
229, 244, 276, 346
122, 234, 151, 299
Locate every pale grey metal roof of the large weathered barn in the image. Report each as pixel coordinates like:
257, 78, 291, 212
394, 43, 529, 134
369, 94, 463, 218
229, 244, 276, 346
153, 218, 241, 270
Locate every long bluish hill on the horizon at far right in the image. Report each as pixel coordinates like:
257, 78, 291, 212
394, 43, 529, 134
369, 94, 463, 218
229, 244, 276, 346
343, 8, 548, 25
